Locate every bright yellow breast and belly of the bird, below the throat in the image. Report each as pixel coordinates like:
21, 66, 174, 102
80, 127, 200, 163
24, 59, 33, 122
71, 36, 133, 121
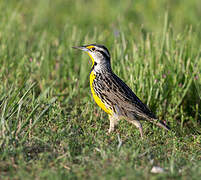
90, 71, 113, 115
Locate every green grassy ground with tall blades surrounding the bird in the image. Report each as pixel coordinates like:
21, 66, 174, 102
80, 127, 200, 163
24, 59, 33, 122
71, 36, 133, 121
0, 0, 201, 179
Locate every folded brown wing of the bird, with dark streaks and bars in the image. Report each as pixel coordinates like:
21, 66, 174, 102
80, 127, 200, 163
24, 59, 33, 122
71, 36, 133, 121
101, 73, 156, 119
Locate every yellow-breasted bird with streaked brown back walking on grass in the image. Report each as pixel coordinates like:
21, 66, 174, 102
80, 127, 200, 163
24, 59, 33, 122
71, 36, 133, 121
73, 44, 170, 138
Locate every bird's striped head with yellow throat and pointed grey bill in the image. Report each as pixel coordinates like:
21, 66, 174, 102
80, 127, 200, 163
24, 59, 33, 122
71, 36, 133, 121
73, 44, 110, 68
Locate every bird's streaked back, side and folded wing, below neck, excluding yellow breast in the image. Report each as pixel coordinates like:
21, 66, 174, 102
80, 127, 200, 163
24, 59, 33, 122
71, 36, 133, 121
93, 71, 156, 120
